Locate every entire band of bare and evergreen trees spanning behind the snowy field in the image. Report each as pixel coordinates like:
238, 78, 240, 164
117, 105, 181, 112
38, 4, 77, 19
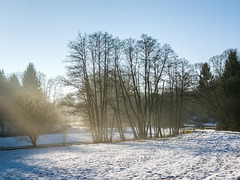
0, 32, 240, 144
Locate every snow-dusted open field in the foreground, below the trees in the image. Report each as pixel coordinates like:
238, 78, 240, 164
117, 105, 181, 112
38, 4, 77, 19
0, 131, 240, 180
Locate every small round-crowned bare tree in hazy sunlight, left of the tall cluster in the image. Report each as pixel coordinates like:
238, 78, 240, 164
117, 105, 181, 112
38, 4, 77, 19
14, 93, 59, 147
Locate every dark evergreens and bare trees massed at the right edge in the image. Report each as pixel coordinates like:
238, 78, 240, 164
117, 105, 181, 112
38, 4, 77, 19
194, 49, 240, 131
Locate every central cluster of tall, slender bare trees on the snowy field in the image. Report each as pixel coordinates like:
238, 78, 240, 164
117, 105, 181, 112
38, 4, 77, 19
64, 32, 190, 142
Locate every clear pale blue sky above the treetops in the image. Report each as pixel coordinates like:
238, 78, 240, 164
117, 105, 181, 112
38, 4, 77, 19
0, 0, 240, 77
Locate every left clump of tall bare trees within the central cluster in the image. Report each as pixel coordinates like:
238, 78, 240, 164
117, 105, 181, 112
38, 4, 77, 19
64, 32, 125, 142
